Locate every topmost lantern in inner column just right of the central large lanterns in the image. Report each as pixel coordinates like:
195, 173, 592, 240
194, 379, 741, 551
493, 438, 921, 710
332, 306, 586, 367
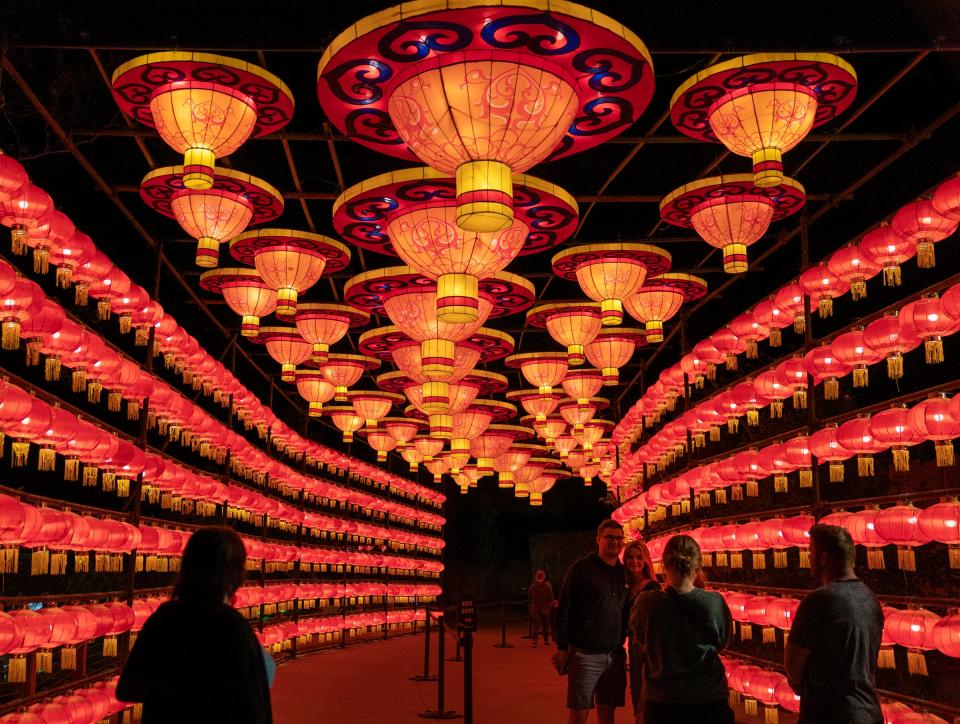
552, 242, 671, 326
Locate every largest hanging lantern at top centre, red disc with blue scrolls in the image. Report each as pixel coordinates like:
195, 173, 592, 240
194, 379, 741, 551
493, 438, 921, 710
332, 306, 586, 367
317, 1, 653, 232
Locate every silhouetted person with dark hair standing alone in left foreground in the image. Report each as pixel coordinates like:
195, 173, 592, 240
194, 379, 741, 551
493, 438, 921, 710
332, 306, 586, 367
117, 527, 272, 724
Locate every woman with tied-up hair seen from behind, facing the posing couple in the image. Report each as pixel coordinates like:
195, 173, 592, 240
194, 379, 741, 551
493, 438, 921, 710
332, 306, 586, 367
630, 535, 734, 724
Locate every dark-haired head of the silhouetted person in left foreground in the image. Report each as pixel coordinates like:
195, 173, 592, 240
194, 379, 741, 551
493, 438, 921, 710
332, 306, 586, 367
173, 526, 247, 604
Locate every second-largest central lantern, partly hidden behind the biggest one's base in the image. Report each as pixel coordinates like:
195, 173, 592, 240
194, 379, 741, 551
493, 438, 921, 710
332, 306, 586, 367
333, 168, 577, 323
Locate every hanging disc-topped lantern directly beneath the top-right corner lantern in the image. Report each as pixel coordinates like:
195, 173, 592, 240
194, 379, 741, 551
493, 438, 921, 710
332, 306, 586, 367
660, 174, 806, 274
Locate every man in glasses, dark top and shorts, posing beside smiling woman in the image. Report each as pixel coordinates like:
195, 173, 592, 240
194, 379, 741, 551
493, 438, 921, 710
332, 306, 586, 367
553, 520, 628, 724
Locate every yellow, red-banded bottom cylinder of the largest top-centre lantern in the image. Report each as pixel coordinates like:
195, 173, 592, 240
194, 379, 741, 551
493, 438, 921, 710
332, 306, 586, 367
457, 161, 513, 232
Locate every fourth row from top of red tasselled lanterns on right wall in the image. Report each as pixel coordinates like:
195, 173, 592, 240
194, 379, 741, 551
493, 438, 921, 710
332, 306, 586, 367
628, 500, 960, 571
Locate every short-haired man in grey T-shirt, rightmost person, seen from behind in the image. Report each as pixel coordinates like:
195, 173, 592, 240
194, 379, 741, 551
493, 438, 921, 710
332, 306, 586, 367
785, 525, 883, 724
